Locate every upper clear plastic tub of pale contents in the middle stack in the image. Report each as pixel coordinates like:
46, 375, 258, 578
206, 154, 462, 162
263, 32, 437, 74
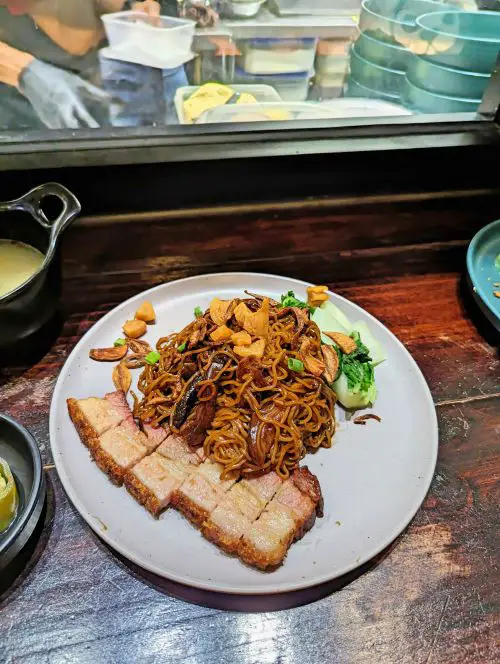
238, 38, 317, 75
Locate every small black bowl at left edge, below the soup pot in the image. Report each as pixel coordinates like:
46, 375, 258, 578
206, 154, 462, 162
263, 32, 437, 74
0, 413, 45, 570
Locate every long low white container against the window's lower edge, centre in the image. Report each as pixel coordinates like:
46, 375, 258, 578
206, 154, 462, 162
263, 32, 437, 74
198, 102, 340, 124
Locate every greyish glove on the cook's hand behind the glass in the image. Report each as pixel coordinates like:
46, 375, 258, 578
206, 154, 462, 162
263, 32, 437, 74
19, 60, 110, 129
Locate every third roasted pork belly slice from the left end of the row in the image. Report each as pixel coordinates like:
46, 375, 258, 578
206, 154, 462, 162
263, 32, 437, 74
124, 452, 190, 517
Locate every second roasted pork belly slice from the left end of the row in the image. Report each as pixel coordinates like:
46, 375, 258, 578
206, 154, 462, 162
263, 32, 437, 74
91, 425, 148, 486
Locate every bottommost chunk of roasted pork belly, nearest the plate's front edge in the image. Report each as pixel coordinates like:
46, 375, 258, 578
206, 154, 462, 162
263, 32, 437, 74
237, 507, 296, 569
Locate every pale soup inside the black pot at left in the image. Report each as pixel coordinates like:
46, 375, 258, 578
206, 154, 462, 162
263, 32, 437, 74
0, 239, 45, 297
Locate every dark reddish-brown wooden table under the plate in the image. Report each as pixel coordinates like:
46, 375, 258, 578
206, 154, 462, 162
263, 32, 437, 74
0, 192, 500, 664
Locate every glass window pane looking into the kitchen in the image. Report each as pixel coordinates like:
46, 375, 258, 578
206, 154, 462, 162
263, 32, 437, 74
0, 0, 500, 134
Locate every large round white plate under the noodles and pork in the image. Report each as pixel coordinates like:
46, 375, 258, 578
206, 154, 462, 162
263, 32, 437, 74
50, 273, 438, 595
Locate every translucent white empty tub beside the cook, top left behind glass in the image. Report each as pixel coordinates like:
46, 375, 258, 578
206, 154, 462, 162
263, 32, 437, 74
102, 12, 196, 69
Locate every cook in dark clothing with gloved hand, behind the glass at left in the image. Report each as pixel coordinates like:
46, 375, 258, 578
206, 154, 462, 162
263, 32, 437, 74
0, 0, 160, 129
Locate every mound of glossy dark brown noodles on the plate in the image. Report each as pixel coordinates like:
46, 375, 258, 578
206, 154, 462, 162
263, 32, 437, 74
134, 300, 335, 478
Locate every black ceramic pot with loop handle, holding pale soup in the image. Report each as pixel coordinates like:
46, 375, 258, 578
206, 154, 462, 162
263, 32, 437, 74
0, 183, 81, 354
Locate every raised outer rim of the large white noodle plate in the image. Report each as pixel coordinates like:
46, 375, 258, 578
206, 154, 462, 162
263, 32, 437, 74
49, 271, 439, 596
